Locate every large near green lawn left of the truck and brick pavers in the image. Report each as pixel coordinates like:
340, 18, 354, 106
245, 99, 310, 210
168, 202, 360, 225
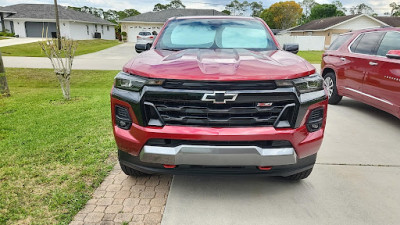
0, 68, 117, 224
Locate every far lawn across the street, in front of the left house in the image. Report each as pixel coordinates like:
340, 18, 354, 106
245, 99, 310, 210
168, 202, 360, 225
0, 39, 119, 57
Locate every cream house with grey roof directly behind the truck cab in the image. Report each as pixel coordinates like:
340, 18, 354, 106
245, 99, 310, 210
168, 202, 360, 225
118, 9, 226, 42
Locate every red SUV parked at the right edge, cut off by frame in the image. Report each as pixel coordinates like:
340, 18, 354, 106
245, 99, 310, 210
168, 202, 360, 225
321, 28, 400, 118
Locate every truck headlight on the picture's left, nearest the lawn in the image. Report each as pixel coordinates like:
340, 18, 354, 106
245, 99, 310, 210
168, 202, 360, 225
114, 71, 164, 91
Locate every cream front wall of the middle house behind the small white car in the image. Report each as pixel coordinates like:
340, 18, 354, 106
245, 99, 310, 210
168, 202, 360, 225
121, 22, 164, 42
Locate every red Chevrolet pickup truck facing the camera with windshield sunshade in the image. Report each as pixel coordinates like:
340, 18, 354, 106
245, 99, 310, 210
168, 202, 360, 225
111, 17, 328, 180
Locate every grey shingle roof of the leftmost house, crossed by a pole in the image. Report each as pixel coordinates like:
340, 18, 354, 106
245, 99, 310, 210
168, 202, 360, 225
1, 4, 115, 25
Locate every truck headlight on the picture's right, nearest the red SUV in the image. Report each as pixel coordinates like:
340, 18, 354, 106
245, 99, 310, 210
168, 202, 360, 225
275, 73, 324, 94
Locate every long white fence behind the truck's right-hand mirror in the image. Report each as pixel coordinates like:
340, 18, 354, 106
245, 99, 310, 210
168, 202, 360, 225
275, 35, 325, 51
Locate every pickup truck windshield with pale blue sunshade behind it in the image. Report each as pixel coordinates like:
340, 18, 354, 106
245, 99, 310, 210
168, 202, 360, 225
156, 19, 277, 51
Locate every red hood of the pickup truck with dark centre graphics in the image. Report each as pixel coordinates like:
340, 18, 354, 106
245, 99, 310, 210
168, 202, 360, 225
123, 49, 315, 81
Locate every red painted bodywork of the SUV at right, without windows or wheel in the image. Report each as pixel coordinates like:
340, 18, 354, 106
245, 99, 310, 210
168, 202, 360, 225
321, 28, 400, 118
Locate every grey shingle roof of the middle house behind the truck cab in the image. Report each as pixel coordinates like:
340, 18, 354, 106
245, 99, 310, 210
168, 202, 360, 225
121, 9, 226, 23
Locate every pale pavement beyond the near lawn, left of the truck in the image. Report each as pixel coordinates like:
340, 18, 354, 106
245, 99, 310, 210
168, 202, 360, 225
3, 43, 137, 70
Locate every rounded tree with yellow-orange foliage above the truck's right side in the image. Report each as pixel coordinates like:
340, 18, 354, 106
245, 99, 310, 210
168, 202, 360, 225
260, 1, 303, 29
